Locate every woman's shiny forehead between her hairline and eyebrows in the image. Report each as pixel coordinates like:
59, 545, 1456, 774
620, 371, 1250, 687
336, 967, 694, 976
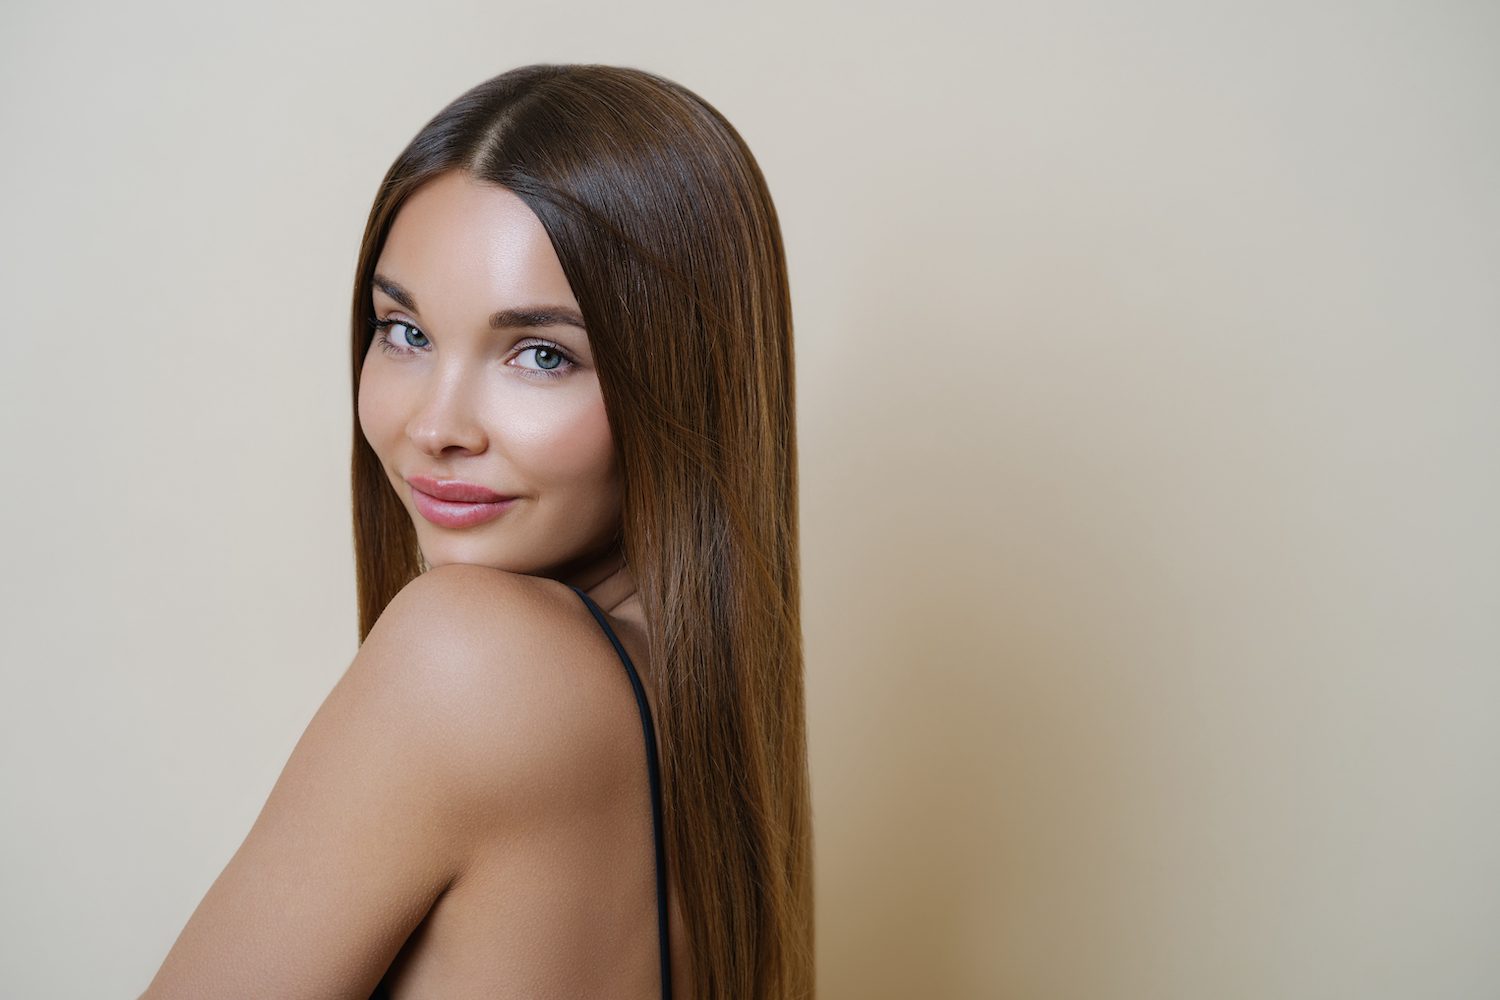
375, 171, 578, 312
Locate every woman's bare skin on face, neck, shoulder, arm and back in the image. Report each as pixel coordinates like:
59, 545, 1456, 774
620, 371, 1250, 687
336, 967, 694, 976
143, 171, 686, 1000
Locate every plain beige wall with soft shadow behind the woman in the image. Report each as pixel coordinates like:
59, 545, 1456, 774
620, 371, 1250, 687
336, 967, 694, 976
0, 0, 1500, 1000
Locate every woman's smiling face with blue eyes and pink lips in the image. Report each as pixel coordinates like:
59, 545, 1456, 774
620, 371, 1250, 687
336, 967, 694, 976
359, 171, 621, 579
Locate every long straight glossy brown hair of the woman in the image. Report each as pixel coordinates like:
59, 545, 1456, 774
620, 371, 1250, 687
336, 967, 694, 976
351, 64, 815, 1000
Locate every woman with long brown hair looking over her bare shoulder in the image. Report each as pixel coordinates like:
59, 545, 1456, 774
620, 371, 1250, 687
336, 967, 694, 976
146, 64, 813, 1000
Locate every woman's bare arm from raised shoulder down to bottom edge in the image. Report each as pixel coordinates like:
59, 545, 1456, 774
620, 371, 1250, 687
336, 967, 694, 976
143, 565, 561, 1000
